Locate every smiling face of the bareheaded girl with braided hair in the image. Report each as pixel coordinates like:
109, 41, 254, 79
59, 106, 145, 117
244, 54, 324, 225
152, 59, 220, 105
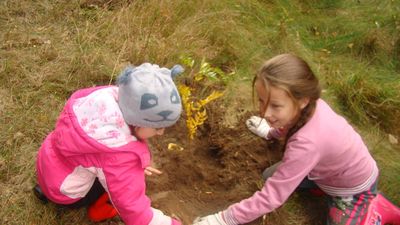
255, 81, 308, 129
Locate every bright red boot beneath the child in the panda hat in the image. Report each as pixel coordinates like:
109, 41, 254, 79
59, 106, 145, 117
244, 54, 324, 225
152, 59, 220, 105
87, 192, 118, 222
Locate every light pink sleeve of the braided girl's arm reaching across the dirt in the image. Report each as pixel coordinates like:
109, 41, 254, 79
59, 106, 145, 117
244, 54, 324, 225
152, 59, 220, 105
224, 136, 319, 224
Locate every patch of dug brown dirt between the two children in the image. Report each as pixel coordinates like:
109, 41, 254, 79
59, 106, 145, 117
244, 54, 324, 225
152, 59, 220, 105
147, 101, 323, 225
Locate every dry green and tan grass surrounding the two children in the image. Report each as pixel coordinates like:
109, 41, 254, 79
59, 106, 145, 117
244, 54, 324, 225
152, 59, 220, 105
0, 0, 400, 224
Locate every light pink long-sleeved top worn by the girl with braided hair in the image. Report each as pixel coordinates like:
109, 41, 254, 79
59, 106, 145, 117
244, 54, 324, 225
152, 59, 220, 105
224, 99, 378, 225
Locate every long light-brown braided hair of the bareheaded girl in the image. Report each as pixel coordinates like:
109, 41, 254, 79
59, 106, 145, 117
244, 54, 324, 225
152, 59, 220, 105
253, 54, 321, 146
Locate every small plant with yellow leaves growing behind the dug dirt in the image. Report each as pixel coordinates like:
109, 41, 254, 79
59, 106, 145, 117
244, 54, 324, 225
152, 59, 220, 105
178, 57, 233, 139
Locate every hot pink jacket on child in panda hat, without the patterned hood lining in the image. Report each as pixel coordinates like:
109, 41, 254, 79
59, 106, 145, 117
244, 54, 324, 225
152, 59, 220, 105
36, 87, 180, 225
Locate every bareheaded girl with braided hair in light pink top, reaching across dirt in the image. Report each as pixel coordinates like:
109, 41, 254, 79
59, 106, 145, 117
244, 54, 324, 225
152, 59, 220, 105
194, 54, 379, 225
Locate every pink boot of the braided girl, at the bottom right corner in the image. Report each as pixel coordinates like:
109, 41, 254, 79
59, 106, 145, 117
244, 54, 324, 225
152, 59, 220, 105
361, 193, 400, 225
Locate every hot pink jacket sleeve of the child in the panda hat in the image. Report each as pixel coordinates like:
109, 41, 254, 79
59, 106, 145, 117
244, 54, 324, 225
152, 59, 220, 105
103, 152, 153, 225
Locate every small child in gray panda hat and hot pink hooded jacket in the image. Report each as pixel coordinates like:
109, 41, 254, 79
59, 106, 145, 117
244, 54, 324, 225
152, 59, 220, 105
35, 63, 182, 225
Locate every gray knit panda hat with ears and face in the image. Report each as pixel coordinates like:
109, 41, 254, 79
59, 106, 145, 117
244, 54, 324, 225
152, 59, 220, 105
117, 63, 183, 128
